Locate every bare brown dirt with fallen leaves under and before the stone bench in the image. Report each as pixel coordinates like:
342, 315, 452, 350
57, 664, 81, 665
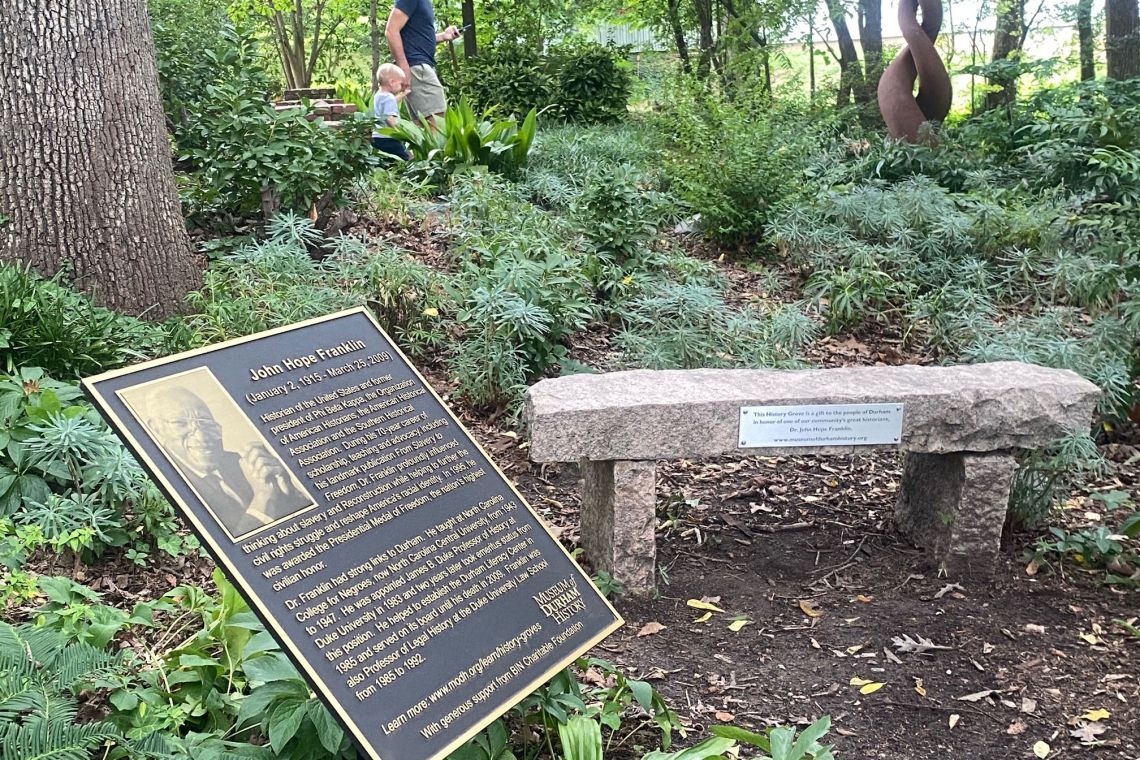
515, 457, 1140, 759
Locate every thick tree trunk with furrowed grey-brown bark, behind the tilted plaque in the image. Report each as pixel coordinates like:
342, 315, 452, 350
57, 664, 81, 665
0, 0, 202, 319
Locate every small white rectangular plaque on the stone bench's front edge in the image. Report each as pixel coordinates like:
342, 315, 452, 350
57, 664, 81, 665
740, 403, 903, 449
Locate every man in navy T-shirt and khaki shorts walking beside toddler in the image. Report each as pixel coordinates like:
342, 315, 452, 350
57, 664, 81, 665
384, 0, 459, 122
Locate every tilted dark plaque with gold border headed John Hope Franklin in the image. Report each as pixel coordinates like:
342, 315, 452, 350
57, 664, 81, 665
83, 309, 621, 760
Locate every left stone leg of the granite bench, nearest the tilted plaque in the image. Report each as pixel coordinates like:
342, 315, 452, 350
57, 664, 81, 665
580, 459, 657, 594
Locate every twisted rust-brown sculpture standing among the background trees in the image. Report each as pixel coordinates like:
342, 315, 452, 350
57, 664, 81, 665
879, 0, 951, 142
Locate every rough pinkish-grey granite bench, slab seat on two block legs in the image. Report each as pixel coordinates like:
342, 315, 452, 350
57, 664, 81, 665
526, 361, 1099, 591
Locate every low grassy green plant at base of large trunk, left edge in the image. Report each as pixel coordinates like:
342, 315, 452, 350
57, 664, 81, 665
0, 264, 164, 378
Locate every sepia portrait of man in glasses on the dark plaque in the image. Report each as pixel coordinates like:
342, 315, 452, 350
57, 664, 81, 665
120, 368, 314, 539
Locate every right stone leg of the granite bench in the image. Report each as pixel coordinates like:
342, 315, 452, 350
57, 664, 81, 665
895, 451, 1017, 577
